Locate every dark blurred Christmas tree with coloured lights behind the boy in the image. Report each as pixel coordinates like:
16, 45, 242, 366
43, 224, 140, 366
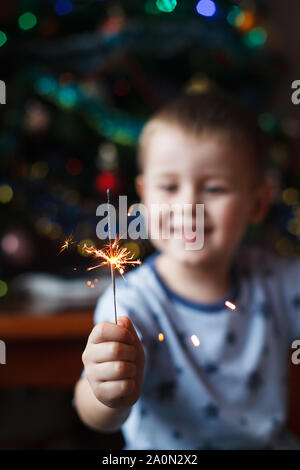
0, 0, 300, 302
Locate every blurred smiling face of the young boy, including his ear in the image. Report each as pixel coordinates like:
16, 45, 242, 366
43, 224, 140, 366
137, 124, 267, 266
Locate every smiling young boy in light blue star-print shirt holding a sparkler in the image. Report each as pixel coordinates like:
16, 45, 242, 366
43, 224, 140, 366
75, 91, 300, 449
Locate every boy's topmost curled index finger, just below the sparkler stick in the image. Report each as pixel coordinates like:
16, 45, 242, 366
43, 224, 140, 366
88, 322, 135, 344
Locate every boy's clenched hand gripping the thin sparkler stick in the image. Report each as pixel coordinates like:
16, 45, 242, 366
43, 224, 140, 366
82, 317, 145, 408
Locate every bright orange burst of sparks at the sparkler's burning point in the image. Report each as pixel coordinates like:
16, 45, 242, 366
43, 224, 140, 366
82, 239, 141, 279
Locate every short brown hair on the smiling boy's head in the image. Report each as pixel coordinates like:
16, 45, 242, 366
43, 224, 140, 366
138, 90, 267, 180
